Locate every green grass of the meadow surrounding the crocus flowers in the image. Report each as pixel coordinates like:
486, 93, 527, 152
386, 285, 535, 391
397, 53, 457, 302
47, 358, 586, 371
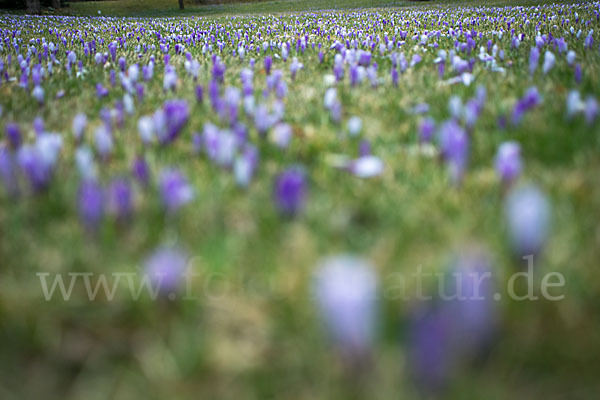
0, 0, 600, 399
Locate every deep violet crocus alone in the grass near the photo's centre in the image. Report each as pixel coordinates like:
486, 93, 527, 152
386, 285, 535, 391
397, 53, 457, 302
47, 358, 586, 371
273, 167, 307, 216
